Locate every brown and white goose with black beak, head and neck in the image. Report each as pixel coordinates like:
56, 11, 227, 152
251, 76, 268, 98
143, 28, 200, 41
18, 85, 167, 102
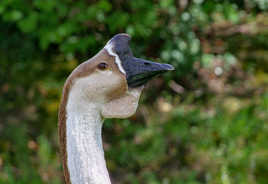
58, 33, 174, 184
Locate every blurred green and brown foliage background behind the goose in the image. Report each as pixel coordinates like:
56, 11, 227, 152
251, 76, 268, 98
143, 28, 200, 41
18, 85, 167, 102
0, 0, 268, 184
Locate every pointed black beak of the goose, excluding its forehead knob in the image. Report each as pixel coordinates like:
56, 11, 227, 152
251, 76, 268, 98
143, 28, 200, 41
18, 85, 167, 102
124, 57, 174, 88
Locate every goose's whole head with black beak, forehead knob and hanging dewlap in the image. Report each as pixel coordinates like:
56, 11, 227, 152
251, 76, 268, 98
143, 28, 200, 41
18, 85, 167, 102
65, 34, 174, 118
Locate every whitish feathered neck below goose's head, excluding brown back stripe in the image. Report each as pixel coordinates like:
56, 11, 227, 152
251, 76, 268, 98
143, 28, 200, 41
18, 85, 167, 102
66, 103, 111, 184
